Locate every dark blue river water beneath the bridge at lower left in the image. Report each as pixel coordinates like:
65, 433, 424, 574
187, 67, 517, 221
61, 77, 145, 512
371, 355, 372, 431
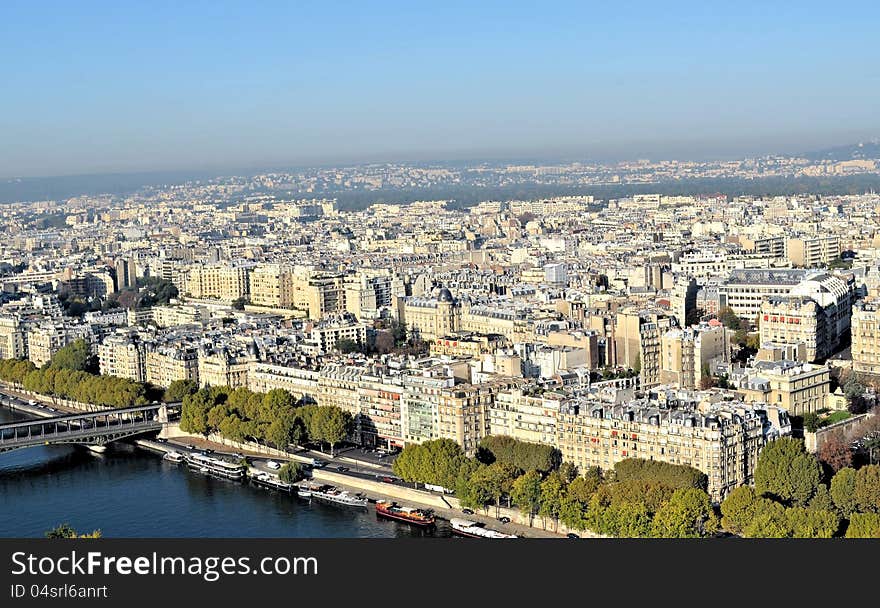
0, 408, 450, 538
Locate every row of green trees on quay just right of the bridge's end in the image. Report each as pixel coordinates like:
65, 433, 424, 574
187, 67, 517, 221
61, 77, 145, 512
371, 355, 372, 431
177, 385, 352, 452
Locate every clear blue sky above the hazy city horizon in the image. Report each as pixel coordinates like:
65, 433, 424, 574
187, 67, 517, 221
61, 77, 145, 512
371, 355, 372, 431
0, 0, 880, 176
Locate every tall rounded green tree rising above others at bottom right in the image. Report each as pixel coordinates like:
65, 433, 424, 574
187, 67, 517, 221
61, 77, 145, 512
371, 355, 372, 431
755, 437, 821, 506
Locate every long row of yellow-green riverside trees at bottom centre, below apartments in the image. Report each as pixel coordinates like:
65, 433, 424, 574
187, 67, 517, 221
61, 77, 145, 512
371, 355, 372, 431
394, 437, 719, 537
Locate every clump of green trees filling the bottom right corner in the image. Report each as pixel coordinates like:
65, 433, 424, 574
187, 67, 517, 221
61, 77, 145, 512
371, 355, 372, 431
721, 437, 880, 538
